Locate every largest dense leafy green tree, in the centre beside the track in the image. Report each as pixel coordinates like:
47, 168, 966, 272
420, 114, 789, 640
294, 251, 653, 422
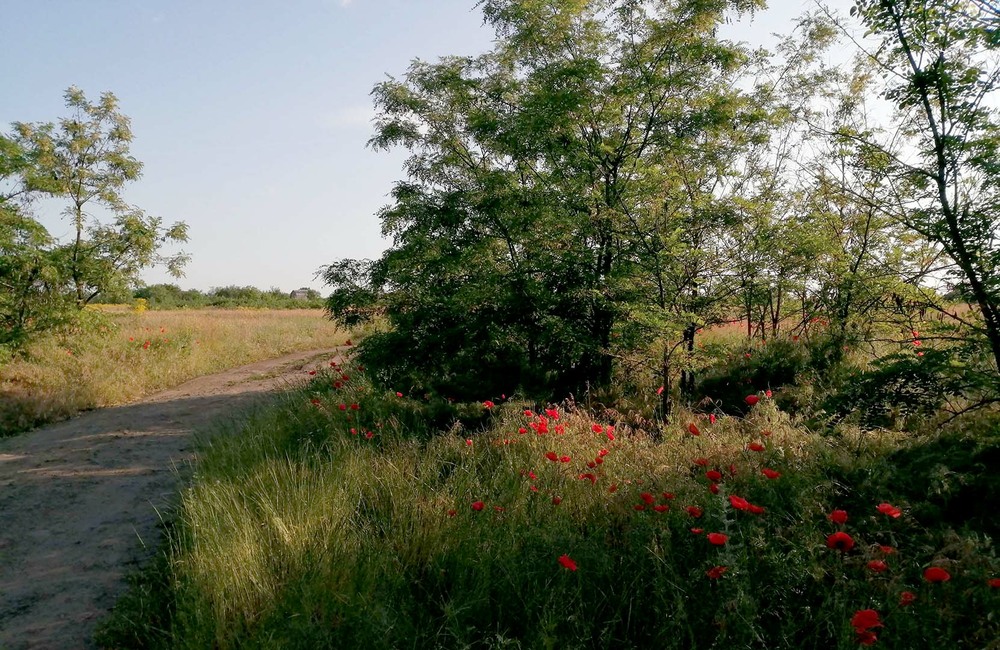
327, 0, 758, 394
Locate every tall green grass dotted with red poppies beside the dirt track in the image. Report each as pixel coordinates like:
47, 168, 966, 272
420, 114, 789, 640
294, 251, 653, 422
99, 369, 1000, 650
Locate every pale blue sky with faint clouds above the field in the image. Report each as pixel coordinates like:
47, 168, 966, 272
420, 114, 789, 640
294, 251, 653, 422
0, 0, 849, 291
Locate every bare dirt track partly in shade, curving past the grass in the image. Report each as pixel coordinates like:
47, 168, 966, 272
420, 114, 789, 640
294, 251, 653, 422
0, 350, 336, 650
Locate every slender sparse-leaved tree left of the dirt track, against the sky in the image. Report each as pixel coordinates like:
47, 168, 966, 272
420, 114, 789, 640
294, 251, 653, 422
14, 87, 187, 307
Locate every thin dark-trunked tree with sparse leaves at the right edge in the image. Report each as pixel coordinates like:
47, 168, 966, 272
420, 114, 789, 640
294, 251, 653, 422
841, 0, 1000, 370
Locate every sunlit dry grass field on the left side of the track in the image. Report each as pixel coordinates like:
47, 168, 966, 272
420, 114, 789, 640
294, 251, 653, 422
0, 309, 348, 436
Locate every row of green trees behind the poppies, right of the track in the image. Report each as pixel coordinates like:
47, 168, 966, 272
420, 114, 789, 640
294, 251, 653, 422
324, 0, 1000, 412
